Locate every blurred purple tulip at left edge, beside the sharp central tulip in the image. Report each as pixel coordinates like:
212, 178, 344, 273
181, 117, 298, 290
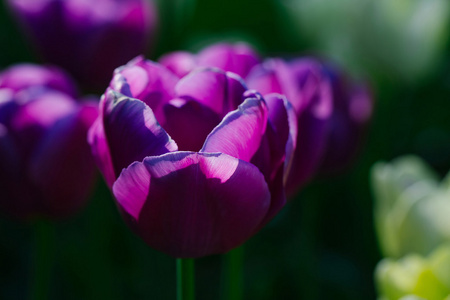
0, 65, 98, 218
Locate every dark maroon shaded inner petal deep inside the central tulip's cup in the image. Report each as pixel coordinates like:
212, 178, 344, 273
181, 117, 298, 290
164, 99, 221, 151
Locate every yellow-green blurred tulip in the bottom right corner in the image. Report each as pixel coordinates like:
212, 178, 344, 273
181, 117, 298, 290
375, 244, 450, 300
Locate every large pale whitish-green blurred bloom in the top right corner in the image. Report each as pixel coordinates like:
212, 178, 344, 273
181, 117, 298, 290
281, 0, 450, 83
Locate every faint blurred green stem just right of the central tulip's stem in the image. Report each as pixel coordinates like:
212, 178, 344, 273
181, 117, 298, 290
222, 246, 244, 300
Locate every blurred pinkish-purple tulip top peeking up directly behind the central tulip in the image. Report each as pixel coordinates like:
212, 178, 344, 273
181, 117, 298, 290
159, 43, 260, 78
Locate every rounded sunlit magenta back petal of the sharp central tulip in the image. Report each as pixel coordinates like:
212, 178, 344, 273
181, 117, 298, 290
175, 69, 247, 116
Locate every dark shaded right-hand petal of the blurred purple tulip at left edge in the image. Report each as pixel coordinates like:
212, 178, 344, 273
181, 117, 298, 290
29, 105, 97, 218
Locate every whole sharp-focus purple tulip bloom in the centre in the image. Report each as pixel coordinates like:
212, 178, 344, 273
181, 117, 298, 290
89, 58, 296, 257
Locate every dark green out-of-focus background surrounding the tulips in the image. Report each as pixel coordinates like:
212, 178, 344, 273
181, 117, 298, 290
0, 0, 450, 300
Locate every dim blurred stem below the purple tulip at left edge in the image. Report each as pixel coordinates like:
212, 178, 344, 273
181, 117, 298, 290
31, 220, 55, 300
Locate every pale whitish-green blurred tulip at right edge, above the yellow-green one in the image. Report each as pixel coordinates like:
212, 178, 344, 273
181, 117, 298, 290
372, 156, 450, 258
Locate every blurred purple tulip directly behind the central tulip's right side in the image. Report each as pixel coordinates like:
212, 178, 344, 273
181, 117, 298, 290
247, 59, 333, 193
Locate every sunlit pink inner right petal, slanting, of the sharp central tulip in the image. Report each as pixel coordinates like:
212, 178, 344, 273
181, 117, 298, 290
201, 98, 267, 162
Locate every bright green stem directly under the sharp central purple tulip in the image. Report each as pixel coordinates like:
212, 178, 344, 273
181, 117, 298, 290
177, 258, 195, 300
